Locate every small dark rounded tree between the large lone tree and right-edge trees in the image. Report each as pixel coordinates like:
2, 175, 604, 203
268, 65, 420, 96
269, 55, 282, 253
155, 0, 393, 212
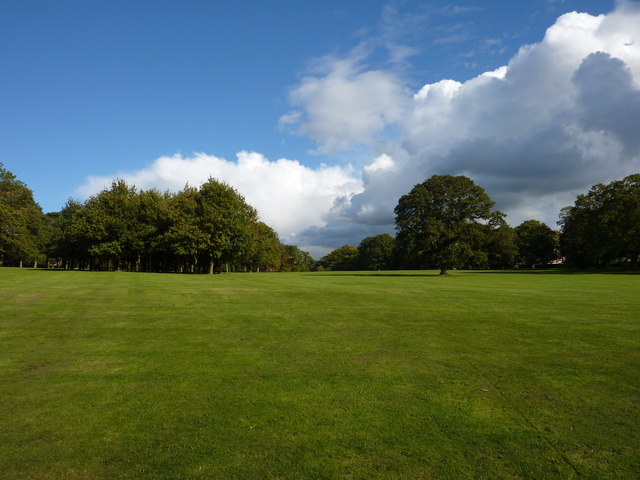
515, 220, 558, 268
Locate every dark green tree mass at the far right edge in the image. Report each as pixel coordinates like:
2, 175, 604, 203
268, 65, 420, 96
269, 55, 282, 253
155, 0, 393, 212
560, 174, 640, 268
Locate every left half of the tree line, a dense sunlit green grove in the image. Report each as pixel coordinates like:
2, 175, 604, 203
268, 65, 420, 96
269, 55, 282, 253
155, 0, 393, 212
0, 164, 314, 273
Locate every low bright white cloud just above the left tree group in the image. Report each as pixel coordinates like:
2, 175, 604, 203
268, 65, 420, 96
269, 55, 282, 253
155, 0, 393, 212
78, 152, 362, 246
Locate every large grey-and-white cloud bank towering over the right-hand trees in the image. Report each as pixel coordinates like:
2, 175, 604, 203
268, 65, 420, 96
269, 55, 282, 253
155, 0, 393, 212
296, 2, 640, 246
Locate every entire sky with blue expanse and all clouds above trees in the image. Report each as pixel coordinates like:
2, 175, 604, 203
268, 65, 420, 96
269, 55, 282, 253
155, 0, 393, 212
0, 0, 640, 257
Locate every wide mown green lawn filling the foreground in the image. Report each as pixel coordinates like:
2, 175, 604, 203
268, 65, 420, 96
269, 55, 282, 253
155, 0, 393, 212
0, 268, 640, 480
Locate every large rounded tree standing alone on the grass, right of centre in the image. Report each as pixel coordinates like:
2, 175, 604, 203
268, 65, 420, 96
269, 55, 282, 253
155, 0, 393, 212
395, 175, 494, 275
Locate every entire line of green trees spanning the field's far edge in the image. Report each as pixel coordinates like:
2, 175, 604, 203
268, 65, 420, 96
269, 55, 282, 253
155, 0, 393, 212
0, 163, 640, 273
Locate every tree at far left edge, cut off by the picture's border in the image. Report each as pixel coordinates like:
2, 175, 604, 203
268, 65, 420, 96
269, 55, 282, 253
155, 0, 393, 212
0, 163, 44, 266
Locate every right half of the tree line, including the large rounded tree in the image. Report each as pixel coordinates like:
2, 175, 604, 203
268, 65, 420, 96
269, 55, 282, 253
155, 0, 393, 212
319, 174, 640, 274
